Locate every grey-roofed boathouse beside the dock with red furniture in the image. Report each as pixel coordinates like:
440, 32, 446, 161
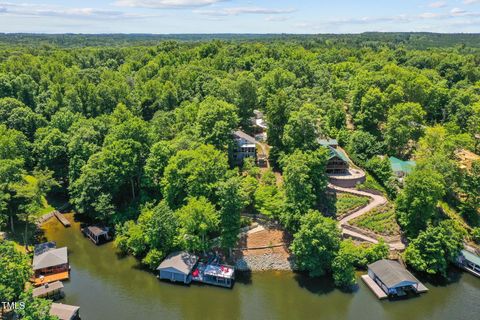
157, 251, 198, 283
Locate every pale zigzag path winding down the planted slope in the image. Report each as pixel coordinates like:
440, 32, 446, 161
328, 183, 405, 250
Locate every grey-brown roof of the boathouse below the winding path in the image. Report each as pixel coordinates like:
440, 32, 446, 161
368, 259, 420, 288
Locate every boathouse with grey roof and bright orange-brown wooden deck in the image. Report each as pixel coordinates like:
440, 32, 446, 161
32, 242, 70, 285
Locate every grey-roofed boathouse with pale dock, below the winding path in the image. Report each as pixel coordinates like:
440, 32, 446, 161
366, 259, 428, 296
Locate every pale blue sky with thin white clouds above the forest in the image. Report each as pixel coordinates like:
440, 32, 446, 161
0, 0, 480, 34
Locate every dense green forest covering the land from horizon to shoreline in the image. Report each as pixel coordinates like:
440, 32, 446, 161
0, 33, 480, 316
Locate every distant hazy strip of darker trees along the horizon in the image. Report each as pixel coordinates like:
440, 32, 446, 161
0, 31, 480, 49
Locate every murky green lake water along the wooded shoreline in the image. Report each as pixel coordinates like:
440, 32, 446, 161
45, 215, 480, 320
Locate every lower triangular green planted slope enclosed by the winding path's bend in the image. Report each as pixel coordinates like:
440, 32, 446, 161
350, 205, 400, 236
